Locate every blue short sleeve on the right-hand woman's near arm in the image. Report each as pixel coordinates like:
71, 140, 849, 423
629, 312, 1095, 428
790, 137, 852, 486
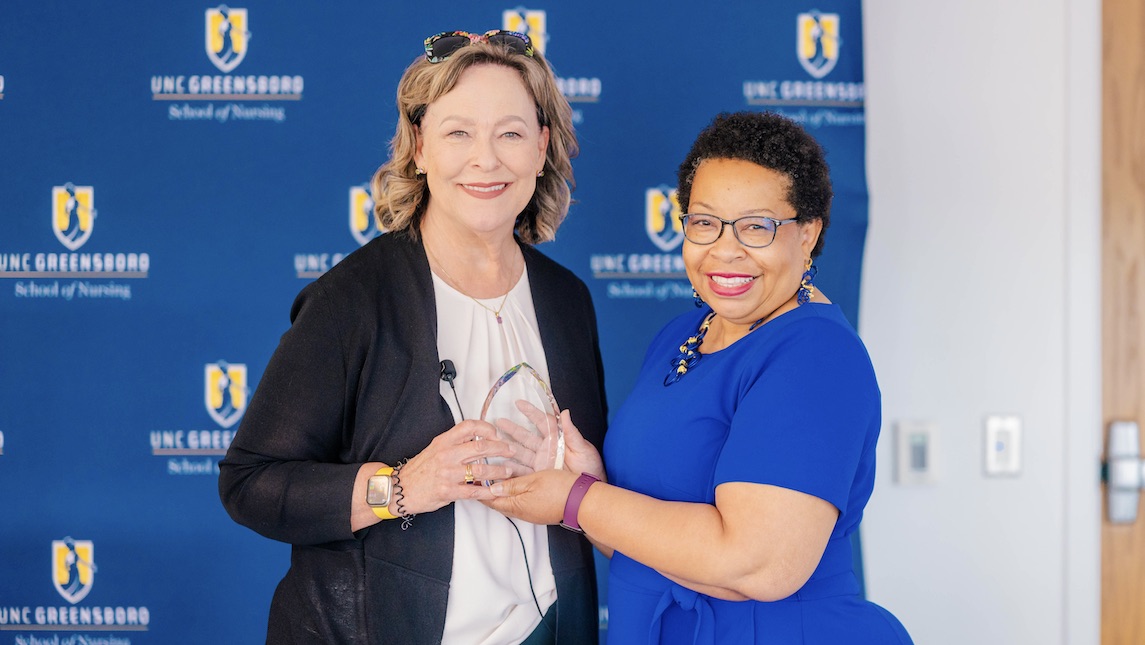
714, 316, 881, 514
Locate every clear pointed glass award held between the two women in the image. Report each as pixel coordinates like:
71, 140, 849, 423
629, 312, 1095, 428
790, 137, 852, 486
481, 363, 564, 483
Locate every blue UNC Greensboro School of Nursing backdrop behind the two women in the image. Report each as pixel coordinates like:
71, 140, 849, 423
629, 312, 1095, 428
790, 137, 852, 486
0, 0, 867, 645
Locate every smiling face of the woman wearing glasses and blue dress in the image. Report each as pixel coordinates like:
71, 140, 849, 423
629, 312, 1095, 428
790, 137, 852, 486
684, 158, 822, 329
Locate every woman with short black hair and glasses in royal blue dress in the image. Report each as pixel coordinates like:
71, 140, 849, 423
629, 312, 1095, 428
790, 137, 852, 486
491, 112, 911, 645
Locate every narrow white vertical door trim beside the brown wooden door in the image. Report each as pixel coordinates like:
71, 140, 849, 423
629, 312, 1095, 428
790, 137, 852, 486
1062, 0, 1104, 645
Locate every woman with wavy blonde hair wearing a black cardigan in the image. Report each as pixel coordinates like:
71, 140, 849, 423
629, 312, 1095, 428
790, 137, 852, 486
219, 31, 606, 645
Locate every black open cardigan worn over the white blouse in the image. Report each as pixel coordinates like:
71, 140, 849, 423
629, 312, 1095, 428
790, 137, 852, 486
219, 234, 607, 645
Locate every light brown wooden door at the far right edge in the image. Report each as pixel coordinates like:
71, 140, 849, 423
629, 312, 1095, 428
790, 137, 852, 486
1099, 0, 1145, 644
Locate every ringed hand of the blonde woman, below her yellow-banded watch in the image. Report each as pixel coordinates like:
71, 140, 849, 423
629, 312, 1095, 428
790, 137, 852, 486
390, 419, 531, 514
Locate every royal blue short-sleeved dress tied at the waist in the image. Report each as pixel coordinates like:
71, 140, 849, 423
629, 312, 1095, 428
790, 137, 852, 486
605, 304, 911, 645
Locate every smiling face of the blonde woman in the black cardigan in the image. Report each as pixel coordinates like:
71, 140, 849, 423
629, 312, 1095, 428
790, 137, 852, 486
414, 64, 548, 236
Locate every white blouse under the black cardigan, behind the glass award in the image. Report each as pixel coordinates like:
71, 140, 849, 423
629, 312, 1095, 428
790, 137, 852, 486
433, 269, 556, 645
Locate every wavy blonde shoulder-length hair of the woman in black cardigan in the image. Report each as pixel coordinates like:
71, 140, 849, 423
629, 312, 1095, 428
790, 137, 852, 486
370, 42, 579, 244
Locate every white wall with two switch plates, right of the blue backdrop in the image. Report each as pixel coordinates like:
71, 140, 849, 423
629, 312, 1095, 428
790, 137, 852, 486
860, 0, 1100, 645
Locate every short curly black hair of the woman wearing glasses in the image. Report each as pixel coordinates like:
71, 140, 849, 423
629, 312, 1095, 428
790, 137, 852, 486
677, 112, 834, 258
